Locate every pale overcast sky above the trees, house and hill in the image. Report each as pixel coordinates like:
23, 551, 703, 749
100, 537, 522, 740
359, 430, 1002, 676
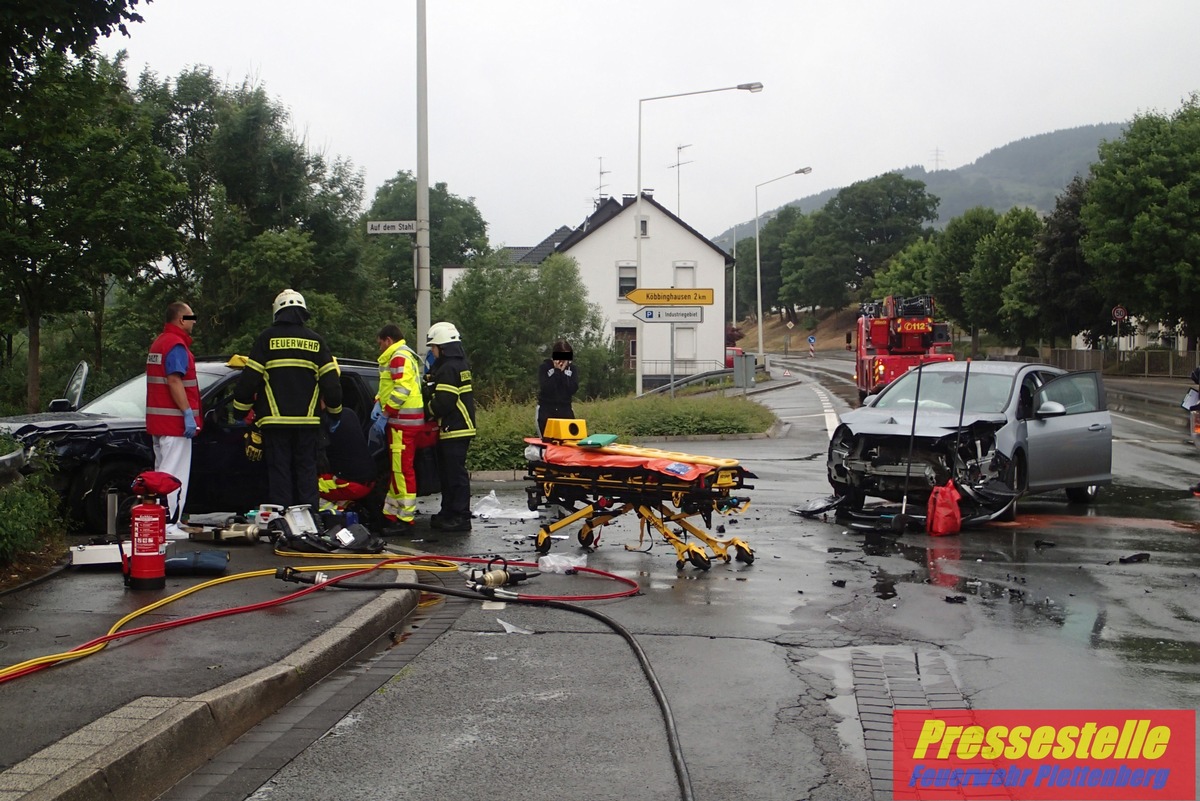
101, 0, 1200, 246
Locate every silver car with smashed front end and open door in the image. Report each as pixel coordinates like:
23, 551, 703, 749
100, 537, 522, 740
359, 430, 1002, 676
828, 361, 1112, 519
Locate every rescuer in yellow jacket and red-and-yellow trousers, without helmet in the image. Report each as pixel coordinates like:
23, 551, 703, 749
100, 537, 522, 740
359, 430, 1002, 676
372, 324, 425, 525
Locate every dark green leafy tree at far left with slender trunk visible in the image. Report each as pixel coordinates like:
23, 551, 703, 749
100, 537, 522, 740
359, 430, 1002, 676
0, 53, 179, 411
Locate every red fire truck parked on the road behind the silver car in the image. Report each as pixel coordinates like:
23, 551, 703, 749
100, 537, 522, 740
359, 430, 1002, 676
854, 295, 954, 401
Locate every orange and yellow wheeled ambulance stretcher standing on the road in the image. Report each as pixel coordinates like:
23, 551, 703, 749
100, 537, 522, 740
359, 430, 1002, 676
526, 420, 756, 570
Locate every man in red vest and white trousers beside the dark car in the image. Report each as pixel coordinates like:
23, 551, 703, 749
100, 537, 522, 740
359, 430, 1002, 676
146, 301, 202, 540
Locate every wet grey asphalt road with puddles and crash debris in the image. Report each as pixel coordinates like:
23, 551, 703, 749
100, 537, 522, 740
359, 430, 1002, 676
163, 364, 1200, 801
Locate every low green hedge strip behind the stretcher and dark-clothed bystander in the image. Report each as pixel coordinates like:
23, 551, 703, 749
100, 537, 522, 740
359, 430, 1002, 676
467, 396, 775, 470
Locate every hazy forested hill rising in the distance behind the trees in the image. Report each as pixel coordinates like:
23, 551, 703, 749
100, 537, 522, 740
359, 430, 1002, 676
713, 122, 1127, 247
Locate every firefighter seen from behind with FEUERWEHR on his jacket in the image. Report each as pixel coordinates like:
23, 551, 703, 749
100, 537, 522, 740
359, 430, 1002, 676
233, 289, 342, 514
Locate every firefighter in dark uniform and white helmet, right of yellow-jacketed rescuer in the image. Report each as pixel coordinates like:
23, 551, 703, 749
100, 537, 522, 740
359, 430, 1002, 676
424, 323, 475, 531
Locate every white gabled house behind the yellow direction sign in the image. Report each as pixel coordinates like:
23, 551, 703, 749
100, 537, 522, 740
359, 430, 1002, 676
556, 193, 732, 387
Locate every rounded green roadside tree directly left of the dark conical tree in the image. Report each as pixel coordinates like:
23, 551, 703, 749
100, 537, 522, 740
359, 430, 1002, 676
962, 207, 1042, 338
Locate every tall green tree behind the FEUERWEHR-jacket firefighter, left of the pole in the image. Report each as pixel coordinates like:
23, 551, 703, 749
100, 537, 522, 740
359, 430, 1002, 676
127, 67, 376, 357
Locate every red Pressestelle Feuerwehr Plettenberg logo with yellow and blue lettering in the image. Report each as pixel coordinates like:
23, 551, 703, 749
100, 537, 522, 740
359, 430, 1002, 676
892, 710, 1196, 801
